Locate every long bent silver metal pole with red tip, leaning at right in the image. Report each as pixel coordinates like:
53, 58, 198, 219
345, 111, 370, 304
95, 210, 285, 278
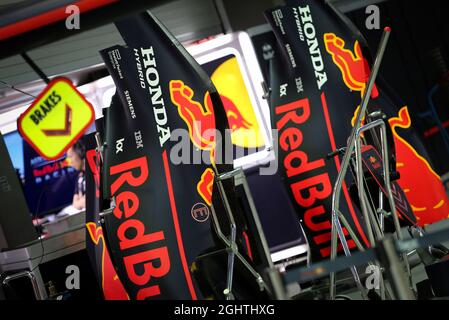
329, 28, 391, 300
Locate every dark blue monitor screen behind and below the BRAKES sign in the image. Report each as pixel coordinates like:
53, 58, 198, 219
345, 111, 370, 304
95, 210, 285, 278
4, 131, 78, 217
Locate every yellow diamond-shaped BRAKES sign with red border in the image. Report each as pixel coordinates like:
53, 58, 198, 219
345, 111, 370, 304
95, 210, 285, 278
17, 78, 95, 160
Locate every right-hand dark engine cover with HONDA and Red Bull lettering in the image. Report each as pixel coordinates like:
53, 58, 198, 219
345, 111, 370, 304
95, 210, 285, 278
266, 1, 376, 261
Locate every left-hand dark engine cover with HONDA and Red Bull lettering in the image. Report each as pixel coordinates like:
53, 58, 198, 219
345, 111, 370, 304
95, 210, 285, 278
101, 13, 260, 300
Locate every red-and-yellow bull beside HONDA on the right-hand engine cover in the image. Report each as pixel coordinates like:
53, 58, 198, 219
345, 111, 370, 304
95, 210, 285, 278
324, 33, 379, 98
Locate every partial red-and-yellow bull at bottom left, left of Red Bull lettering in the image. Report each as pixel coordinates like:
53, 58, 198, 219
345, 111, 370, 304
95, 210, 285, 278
86, 222, 129, 300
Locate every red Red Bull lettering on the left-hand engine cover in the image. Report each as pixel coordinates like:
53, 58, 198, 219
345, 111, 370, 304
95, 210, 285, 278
109, 156, 171, 300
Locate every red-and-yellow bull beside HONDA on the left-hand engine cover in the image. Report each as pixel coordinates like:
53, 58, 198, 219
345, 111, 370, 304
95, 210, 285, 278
170, 80, 216, 206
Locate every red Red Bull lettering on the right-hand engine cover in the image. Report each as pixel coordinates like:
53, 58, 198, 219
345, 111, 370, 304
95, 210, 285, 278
274, 95, 358, 258
